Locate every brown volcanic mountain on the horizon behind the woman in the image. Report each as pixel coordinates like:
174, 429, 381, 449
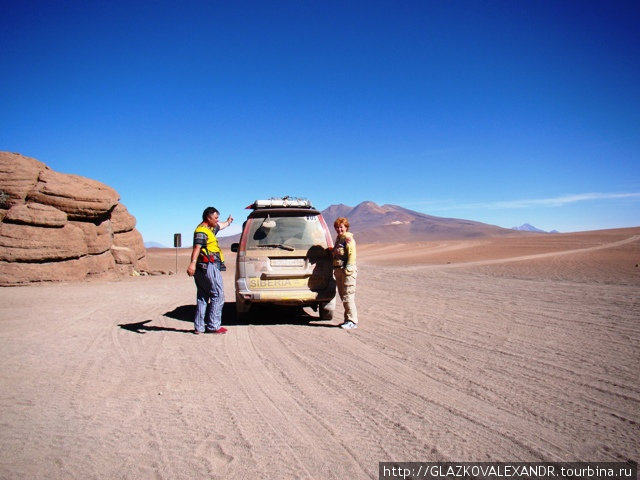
322, 201, 514, 243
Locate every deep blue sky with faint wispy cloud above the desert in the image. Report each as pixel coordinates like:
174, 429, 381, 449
0, 0, 640, 245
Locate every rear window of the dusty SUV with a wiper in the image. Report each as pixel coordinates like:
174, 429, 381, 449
247, 215, 327, 251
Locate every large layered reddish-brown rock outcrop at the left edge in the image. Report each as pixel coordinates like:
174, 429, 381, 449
0, 152, 148, 286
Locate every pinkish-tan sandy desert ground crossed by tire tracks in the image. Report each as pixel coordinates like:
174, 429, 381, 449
0, 228, 640, 480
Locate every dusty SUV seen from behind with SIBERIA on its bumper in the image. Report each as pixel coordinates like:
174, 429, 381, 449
231, 197, 336, 320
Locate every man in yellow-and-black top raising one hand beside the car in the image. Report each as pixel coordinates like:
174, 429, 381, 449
187, 207, 233, 335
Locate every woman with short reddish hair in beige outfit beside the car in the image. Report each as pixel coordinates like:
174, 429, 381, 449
333, 217, 358, 330
